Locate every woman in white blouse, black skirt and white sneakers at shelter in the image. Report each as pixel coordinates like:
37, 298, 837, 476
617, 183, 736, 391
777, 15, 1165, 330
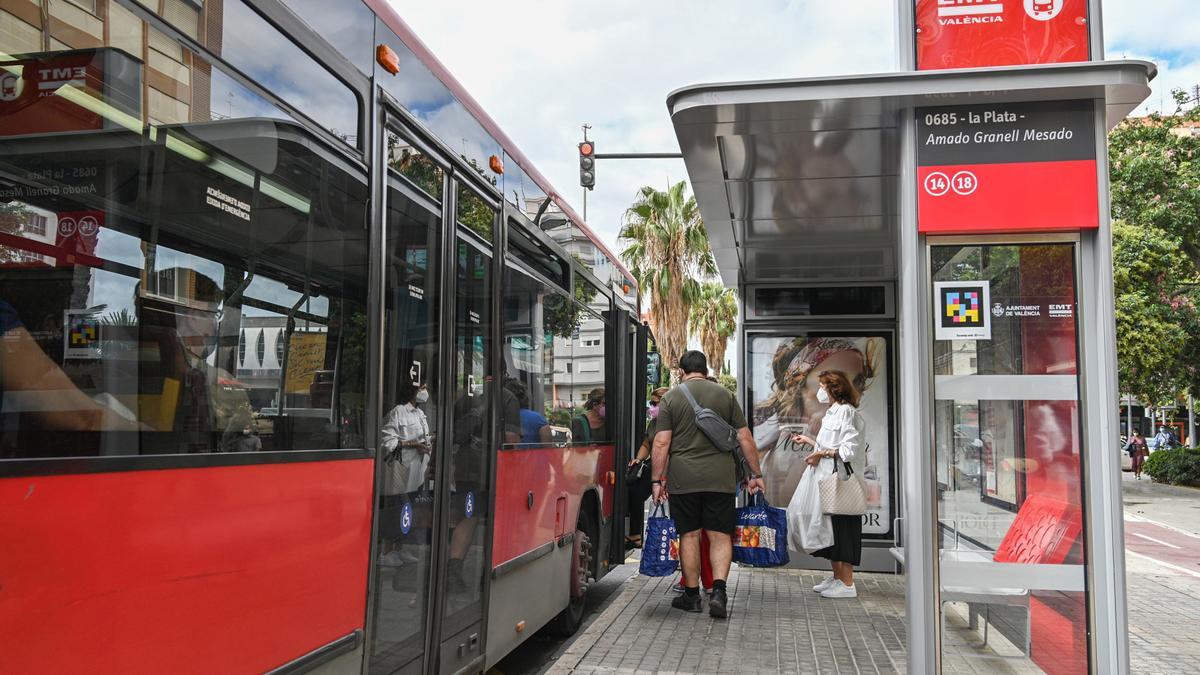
793, 370, 866, 598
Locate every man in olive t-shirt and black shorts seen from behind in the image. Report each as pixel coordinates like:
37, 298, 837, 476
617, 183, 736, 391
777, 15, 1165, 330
650, 350, 763, 619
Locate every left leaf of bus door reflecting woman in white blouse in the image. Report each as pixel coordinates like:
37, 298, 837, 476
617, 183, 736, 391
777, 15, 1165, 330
367, 129, 449, 673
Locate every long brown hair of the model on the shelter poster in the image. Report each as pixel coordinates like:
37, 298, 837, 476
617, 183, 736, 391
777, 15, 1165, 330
754, 338, 882, 424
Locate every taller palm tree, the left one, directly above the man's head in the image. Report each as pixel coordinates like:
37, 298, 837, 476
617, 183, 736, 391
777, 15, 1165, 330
619, 181, 716, 369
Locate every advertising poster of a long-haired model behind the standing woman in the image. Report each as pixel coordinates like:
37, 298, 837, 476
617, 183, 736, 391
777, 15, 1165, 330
746, 334, 893, 536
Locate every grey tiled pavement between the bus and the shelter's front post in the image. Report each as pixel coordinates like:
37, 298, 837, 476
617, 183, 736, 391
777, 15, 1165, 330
548, 566, 905, 674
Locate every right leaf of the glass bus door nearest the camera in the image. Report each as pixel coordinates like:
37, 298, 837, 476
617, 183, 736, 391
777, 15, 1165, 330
436, 183, 496, 673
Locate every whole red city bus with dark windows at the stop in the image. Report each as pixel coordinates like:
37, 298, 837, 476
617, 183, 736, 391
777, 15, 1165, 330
0, 0, 647, 673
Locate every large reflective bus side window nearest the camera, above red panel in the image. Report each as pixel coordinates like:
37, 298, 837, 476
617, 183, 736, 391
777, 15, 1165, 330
0, 40, 366, 458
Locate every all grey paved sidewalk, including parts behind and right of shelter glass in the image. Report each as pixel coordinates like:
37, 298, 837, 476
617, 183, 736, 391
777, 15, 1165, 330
546, 561, 1200, 675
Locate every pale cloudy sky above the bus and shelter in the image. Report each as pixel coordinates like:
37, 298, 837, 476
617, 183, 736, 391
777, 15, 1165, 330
391, 0, 1200, 266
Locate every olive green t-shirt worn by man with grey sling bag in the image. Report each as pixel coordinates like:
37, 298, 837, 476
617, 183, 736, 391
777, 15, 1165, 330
656, 380, 746, 495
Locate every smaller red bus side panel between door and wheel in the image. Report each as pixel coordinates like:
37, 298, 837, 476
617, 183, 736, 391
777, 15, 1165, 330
492, 446, 617, 567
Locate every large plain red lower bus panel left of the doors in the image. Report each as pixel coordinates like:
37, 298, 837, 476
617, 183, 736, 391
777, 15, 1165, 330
0, 459, 373, 673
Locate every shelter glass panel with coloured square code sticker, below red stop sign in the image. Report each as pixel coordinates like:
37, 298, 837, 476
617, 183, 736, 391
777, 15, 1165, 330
930, 244, 1088, 673
